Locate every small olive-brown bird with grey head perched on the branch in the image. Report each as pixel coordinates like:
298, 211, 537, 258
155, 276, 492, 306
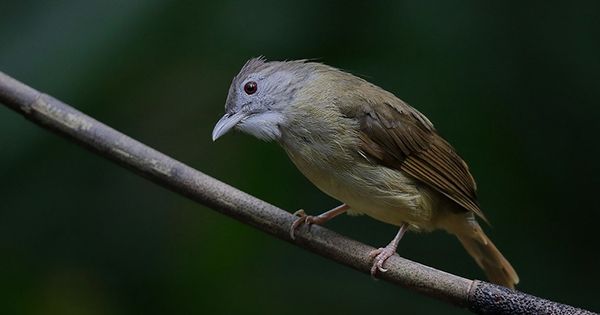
212, 58, 519, 288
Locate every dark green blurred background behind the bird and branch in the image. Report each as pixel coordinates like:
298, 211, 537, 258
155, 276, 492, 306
0, 0, 600, 315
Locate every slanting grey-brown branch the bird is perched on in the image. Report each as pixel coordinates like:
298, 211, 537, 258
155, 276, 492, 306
0, 72, 594, 314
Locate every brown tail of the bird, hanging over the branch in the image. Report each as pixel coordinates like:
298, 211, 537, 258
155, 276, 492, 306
456, 223, 519, 289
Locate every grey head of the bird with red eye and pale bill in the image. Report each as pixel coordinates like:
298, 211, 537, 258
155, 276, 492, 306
212, 58, 313, 140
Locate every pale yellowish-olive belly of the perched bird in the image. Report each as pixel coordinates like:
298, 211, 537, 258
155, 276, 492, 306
292, 154, 433, 230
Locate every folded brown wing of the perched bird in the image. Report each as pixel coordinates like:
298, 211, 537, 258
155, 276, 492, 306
353, 99, 487, 221
